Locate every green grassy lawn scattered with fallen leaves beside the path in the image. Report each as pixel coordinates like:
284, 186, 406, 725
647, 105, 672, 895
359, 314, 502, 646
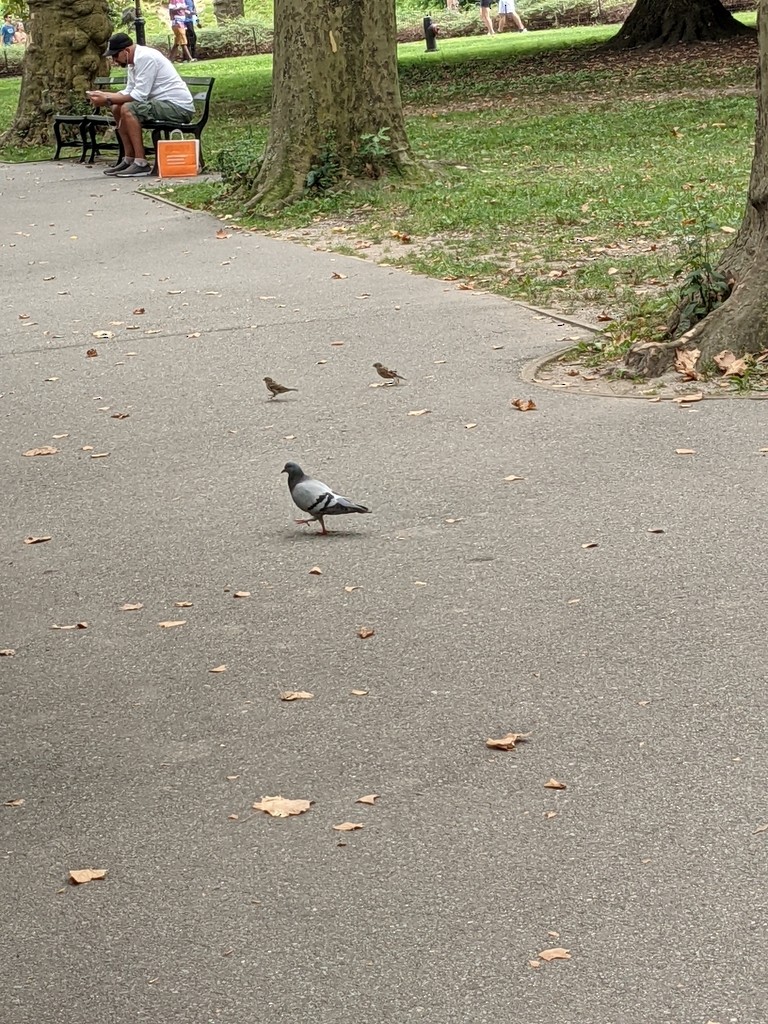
0, 17, 757, 315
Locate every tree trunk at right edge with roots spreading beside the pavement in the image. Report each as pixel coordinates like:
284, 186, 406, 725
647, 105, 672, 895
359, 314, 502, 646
626, 0, 768, 376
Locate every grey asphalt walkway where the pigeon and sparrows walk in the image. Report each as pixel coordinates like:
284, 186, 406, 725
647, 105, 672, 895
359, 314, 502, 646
0, 164, 768, 1024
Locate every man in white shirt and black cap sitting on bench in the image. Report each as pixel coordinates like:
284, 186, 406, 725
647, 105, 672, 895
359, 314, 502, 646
86, 32, 195, 178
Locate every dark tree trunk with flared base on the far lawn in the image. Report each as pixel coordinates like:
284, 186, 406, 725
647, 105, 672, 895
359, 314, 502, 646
608, 0, 753, 49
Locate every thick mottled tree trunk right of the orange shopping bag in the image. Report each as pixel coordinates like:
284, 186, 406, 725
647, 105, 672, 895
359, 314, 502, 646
241, 0, 412, 210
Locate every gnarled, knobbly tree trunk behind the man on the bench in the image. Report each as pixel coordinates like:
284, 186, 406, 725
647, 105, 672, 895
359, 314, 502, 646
0, 0, 112, 145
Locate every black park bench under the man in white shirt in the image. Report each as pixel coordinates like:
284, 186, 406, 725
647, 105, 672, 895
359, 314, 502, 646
53, 76, 216, 174
